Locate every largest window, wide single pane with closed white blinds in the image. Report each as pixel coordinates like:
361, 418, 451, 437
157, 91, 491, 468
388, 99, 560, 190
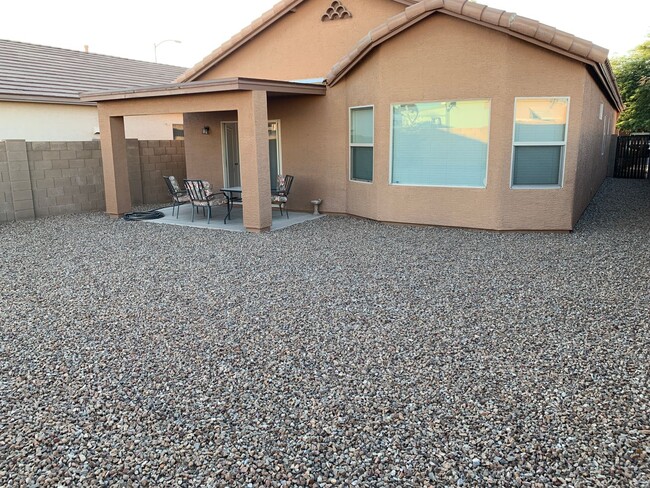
391, 100, 490, 188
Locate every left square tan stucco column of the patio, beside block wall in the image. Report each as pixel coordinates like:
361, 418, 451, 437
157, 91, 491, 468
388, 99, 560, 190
99, 111, 131, 218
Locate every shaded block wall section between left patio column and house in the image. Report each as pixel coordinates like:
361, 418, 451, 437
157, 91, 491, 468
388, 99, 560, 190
140, 141, 187, 203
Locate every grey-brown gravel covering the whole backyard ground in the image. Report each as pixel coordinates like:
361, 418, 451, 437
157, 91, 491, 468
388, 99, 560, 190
0, 180, 650, 487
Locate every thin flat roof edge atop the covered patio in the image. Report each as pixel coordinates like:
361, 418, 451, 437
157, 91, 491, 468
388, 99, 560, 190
81, 77, 327, 102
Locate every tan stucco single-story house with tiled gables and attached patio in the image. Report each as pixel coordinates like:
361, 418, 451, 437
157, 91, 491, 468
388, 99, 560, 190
82, 0, 622, 231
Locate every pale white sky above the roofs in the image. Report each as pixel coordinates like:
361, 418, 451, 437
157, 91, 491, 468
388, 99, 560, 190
0, 0, 650, 70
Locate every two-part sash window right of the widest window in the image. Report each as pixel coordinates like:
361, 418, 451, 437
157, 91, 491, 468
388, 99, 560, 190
512, 97, 569, 188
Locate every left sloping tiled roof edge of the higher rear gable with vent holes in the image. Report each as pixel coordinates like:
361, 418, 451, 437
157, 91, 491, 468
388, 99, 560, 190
175, 0, 420, 83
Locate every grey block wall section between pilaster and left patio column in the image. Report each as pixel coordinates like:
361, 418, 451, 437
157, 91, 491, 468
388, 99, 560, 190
26, 141, 105, 217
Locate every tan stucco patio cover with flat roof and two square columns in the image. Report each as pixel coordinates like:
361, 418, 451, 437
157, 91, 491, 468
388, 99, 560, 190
82, 78, 326, 232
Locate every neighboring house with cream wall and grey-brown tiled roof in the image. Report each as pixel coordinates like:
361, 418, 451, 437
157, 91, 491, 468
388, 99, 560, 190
0, 39, 186, 142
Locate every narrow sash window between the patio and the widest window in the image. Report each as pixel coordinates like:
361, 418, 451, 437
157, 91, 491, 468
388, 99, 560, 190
350, 107, 375, 182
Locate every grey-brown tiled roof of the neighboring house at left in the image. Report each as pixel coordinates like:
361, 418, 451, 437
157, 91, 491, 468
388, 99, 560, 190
0, 39, 185, 105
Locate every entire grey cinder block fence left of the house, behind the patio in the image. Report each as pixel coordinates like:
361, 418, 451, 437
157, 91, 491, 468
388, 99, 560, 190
0, 139, 186, 222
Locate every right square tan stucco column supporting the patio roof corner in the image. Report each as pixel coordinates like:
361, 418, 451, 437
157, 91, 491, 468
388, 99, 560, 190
238, 91, 272, 232
